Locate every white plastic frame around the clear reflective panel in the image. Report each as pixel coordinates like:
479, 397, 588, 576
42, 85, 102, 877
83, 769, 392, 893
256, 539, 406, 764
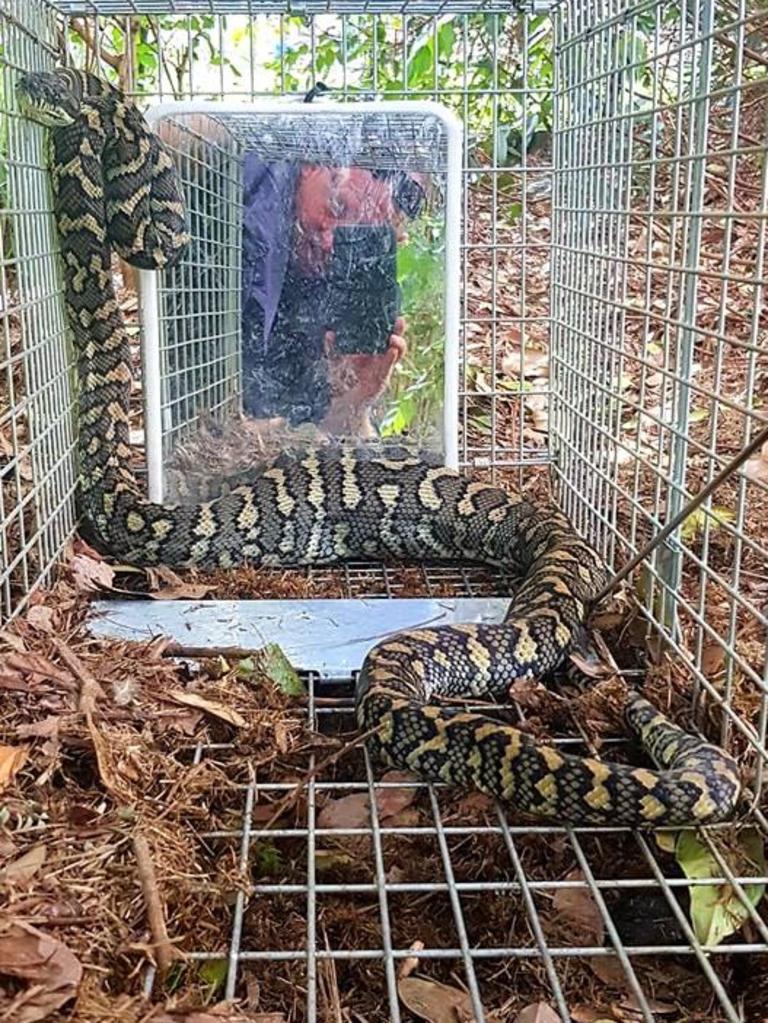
139, 99, 462, 502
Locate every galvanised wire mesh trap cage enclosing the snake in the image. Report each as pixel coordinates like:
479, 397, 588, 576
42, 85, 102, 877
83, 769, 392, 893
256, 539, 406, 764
0, 0, 768, 1021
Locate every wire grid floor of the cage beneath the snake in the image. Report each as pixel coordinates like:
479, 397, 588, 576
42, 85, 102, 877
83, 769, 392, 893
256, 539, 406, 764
83, 564, 768, 1023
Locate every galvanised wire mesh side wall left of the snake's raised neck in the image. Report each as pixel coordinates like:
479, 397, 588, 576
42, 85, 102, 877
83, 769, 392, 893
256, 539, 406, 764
0, 0, 74, 621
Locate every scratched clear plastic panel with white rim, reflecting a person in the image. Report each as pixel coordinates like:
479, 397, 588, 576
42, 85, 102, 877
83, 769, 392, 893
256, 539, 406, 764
142, 102, 461, 500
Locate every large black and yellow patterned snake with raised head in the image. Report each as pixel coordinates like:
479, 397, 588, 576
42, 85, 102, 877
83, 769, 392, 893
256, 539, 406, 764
17, 71, 739, 827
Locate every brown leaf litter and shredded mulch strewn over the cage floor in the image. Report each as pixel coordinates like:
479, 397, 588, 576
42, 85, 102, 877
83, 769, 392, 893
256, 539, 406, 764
0, 578, 764, 1023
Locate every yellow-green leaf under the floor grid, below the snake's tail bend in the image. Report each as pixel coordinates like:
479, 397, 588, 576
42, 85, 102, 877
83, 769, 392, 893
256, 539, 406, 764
675, 828, 766, 945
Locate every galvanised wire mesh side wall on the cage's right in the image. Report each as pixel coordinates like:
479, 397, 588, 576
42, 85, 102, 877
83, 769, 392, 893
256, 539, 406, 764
551, 0, 768, 802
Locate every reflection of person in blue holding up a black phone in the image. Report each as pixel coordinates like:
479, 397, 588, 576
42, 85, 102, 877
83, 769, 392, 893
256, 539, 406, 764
242, 153, 423, 436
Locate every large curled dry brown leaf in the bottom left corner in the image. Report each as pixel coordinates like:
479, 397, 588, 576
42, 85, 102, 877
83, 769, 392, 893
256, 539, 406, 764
0, 923, 83, 1023
